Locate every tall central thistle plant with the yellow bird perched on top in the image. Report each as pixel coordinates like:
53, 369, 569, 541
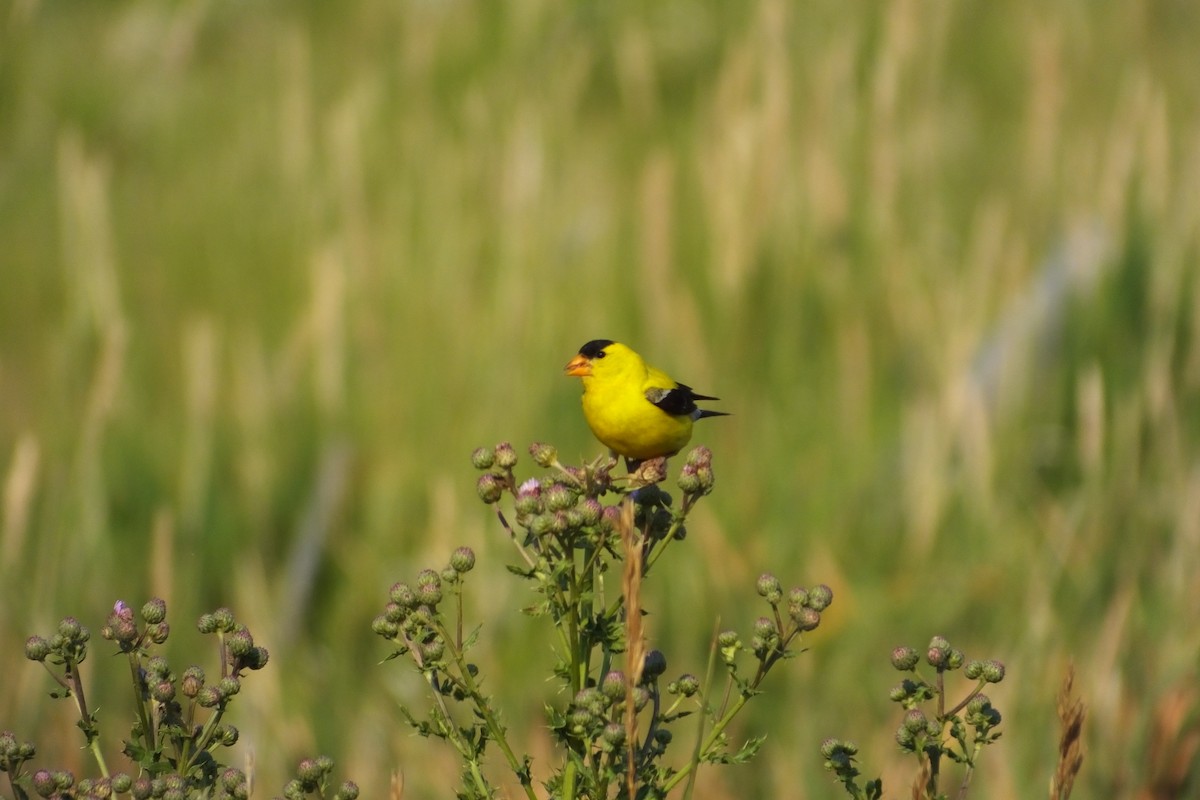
373, 443, 833, 800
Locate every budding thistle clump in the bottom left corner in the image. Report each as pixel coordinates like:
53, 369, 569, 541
10, 599, 358, 800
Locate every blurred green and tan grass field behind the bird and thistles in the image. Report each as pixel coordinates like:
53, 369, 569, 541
0, 0, 1200, 799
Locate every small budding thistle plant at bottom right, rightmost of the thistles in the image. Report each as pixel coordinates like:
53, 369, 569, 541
821, 636, 1004, 800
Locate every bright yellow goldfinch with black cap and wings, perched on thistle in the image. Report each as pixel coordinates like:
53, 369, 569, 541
565, 339, 726, 462
